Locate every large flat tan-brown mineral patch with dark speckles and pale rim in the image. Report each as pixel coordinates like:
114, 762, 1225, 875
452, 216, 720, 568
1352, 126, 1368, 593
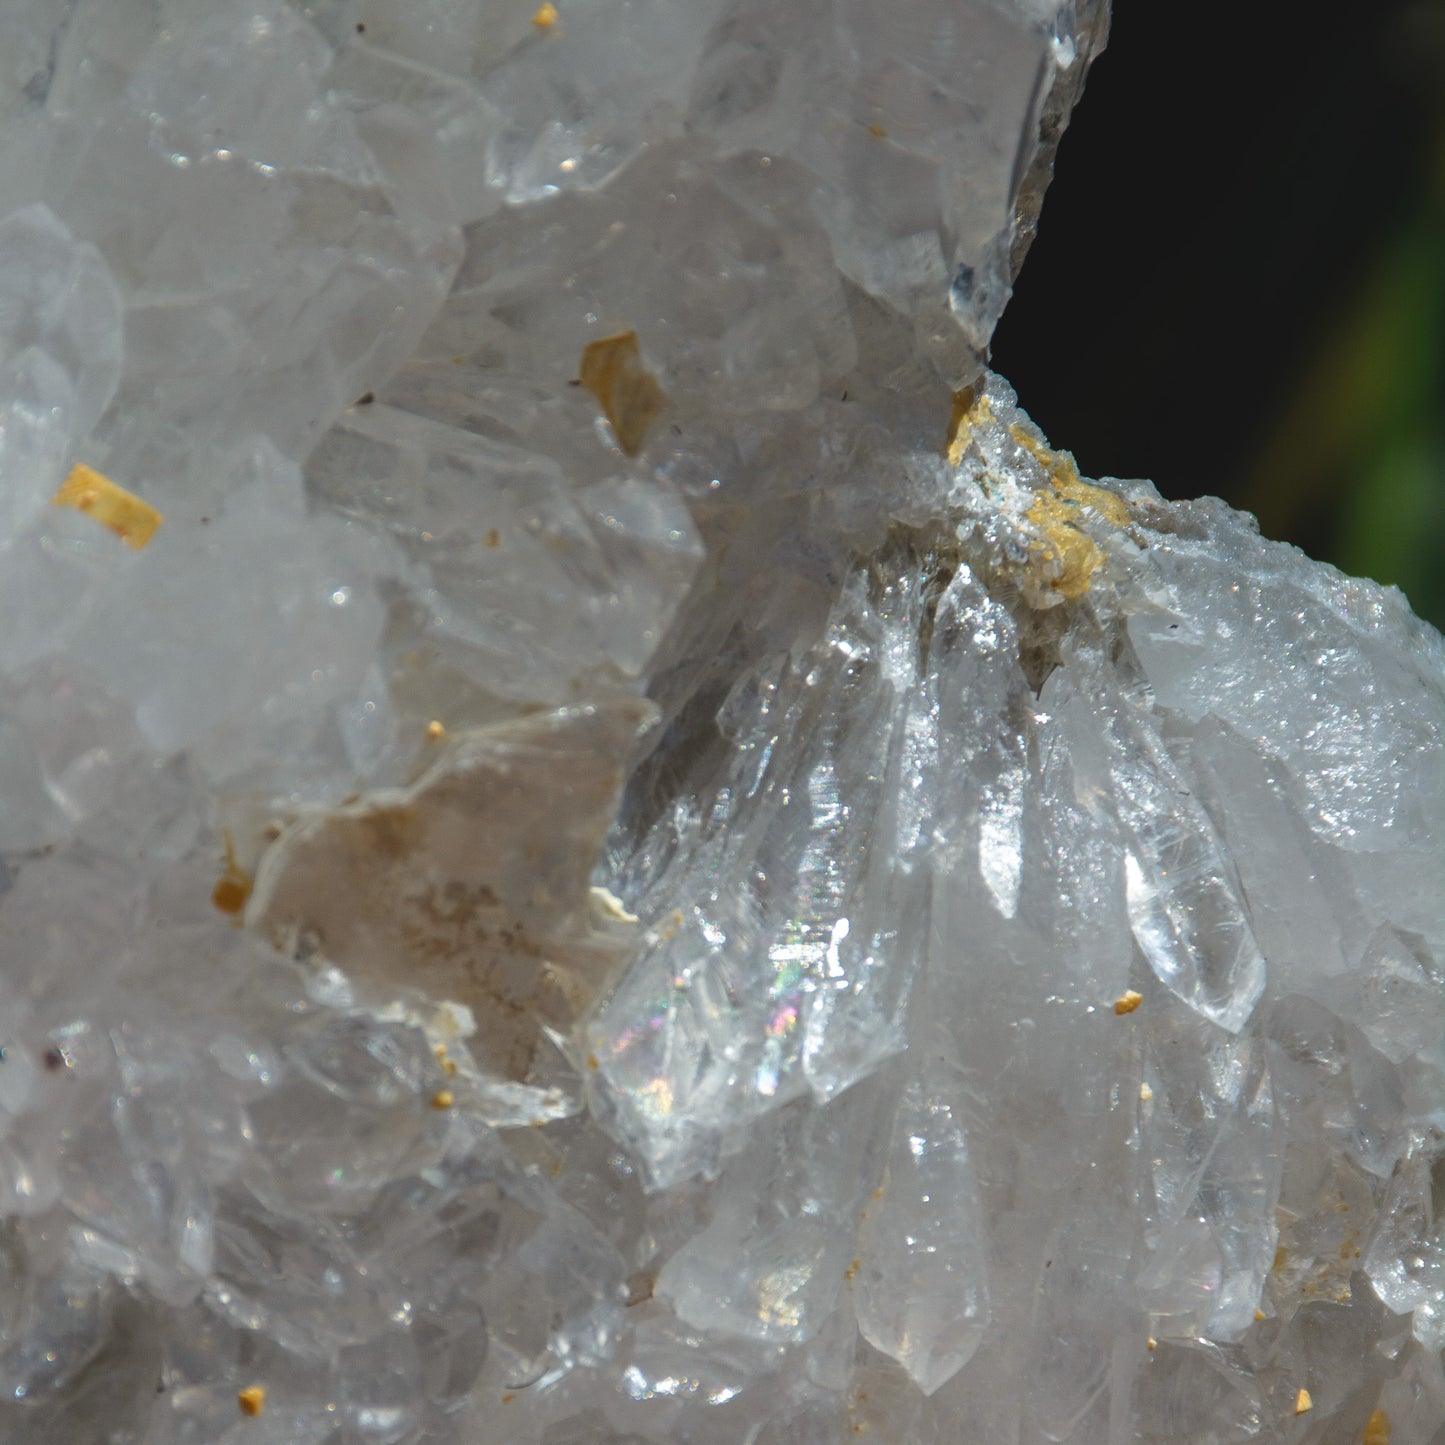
246, 698, 647, 1086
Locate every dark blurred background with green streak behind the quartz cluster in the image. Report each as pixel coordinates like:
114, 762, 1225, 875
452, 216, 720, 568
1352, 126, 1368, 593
993, 0, 1445, 627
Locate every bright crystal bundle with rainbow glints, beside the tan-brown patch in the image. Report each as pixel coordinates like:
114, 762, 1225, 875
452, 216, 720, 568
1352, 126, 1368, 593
585, 554, 931, 1182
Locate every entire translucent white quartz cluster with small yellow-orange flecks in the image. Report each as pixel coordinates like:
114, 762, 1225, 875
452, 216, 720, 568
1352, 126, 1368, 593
0, 0, 1445, 1445
